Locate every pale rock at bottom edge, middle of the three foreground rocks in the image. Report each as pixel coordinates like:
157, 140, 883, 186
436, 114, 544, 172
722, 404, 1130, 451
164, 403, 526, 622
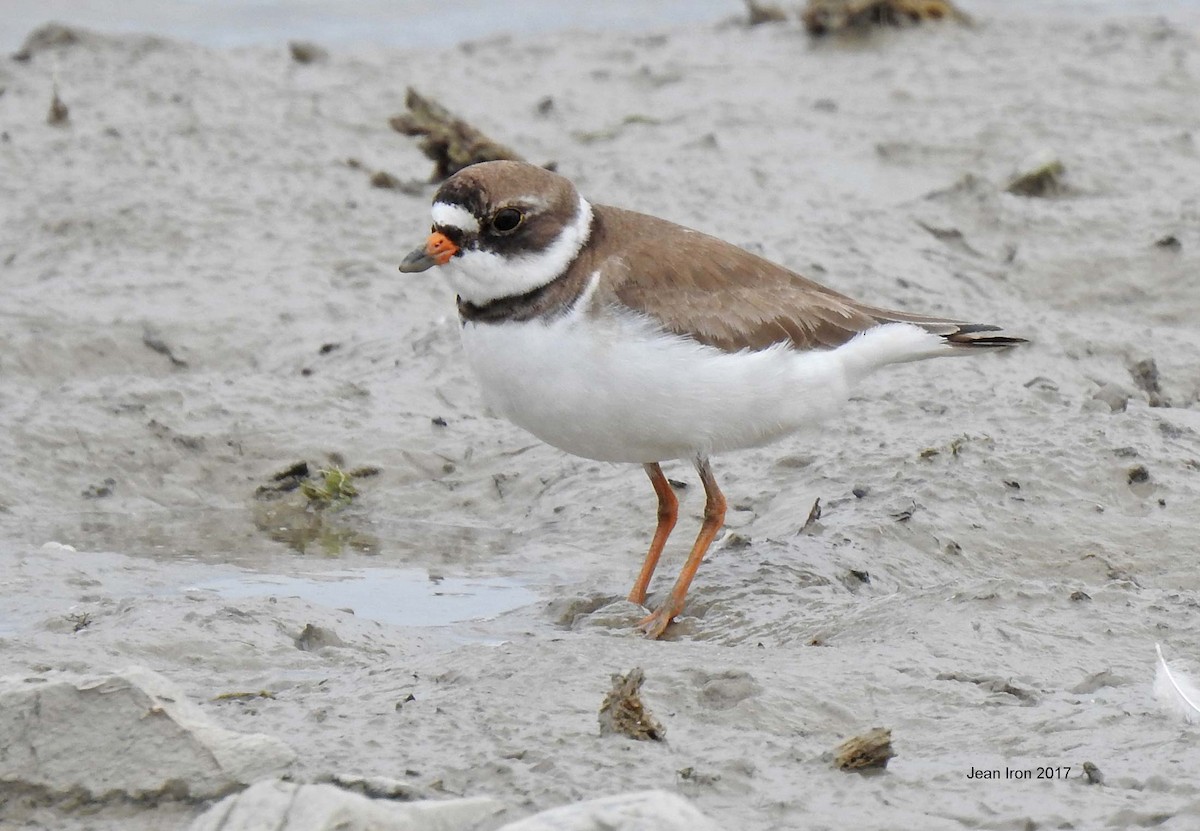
188, 781, 508, 831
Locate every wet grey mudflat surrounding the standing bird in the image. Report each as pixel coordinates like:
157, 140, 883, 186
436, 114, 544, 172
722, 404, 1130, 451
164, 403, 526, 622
0, 8, 1200, 830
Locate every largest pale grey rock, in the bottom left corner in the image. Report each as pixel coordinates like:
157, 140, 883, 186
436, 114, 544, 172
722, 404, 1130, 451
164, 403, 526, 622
0, 666, 295, 800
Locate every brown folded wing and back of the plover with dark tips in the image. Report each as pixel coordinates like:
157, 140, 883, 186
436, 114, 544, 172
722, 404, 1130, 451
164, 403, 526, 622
578, 205, 1020, 352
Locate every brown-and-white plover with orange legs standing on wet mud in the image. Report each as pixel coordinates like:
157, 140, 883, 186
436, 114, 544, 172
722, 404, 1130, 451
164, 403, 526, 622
400, 161, 1022, 638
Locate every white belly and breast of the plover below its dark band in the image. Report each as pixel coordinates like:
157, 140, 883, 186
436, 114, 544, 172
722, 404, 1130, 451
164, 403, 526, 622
462, 284, 952, 462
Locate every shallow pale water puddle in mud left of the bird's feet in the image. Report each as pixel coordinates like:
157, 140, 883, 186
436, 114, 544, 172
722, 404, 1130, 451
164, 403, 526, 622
188, 568, 536, 626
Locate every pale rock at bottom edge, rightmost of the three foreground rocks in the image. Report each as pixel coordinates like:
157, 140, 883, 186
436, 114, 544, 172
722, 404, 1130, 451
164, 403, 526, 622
499, 790, 721, 831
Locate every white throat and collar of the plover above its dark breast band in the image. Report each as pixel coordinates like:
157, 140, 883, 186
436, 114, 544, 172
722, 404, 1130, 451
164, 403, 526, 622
434, 197, 592, 305
